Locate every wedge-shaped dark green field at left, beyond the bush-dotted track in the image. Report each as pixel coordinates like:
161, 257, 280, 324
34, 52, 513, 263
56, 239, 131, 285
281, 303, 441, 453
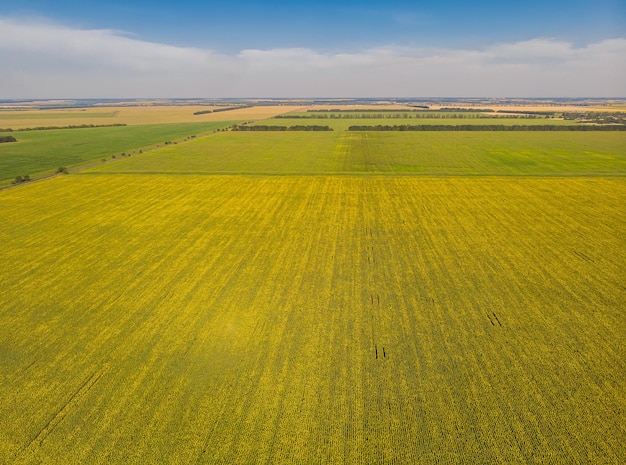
0, 121, 230, 184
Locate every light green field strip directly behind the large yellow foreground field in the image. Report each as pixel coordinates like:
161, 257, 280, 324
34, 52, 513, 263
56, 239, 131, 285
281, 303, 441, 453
90, 131, 626, 176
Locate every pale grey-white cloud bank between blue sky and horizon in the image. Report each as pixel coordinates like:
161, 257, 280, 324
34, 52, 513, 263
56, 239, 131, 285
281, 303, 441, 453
0, 19, 626, 99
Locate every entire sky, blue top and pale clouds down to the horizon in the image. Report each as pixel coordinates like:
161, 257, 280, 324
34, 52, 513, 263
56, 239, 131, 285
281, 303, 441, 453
0, 0, 626, 99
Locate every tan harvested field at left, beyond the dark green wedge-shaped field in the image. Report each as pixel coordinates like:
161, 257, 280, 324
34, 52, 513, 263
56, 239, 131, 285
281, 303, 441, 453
0, 105, 292, 129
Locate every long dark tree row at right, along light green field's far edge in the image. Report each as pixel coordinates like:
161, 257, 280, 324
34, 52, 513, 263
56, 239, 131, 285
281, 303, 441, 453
348, 124, 626, 131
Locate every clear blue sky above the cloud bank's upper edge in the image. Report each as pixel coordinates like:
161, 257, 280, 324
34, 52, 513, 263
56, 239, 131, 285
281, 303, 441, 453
6, 0, 626, 52
